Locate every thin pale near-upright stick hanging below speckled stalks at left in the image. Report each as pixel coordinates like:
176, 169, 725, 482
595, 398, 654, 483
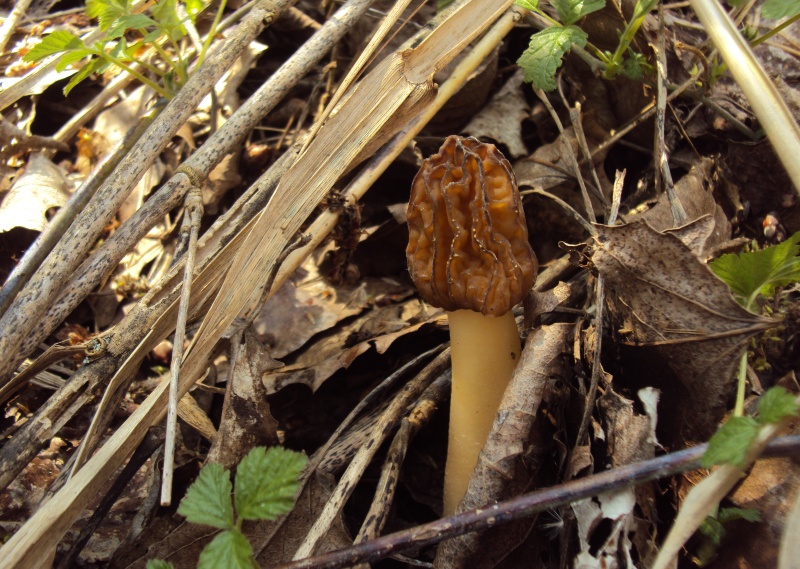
161, 184, 203, 506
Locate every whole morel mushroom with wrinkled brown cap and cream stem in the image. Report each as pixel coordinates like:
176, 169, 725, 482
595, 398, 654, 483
406, 136, 538, 515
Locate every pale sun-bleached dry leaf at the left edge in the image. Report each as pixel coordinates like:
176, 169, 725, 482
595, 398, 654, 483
0, 153, 69, 233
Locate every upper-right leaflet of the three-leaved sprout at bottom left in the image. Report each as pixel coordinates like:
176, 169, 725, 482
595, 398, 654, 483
234, 447, 307, 520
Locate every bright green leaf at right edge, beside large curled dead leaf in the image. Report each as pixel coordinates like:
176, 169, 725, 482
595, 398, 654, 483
711, 232, 800, 307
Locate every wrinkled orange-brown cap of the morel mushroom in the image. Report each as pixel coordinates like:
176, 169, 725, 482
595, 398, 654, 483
406, 136, 538, 316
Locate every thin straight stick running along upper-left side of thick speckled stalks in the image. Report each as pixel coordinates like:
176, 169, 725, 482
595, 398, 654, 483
0, 101, 163, 314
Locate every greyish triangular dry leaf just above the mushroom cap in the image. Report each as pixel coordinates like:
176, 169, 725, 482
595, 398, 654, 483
464, 69, 529, 158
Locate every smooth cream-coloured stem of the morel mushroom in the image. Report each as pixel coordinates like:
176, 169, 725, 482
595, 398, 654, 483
444, 310, 521, 516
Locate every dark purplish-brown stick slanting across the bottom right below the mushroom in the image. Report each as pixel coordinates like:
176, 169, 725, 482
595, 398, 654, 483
273, 435, 800, 569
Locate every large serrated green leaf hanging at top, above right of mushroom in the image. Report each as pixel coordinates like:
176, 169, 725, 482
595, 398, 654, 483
517, 26, 588, 91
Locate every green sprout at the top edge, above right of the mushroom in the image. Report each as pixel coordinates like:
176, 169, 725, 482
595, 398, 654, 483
515, 0, 658, 91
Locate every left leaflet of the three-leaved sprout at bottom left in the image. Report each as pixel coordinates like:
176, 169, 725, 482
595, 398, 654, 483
178, 462, 233, 529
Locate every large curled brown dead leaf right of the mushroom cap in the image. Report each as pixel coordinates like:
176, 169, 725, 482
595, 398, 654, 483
572, 222, 774, 440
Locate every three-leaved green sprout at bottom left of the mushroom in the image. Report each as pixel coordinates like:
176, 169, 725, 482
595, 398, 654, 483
147, 447, 308, 569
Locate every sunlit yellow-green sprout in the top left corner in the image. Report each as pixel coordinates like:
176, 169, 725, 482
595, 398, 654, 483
23, 0, 226, 99
